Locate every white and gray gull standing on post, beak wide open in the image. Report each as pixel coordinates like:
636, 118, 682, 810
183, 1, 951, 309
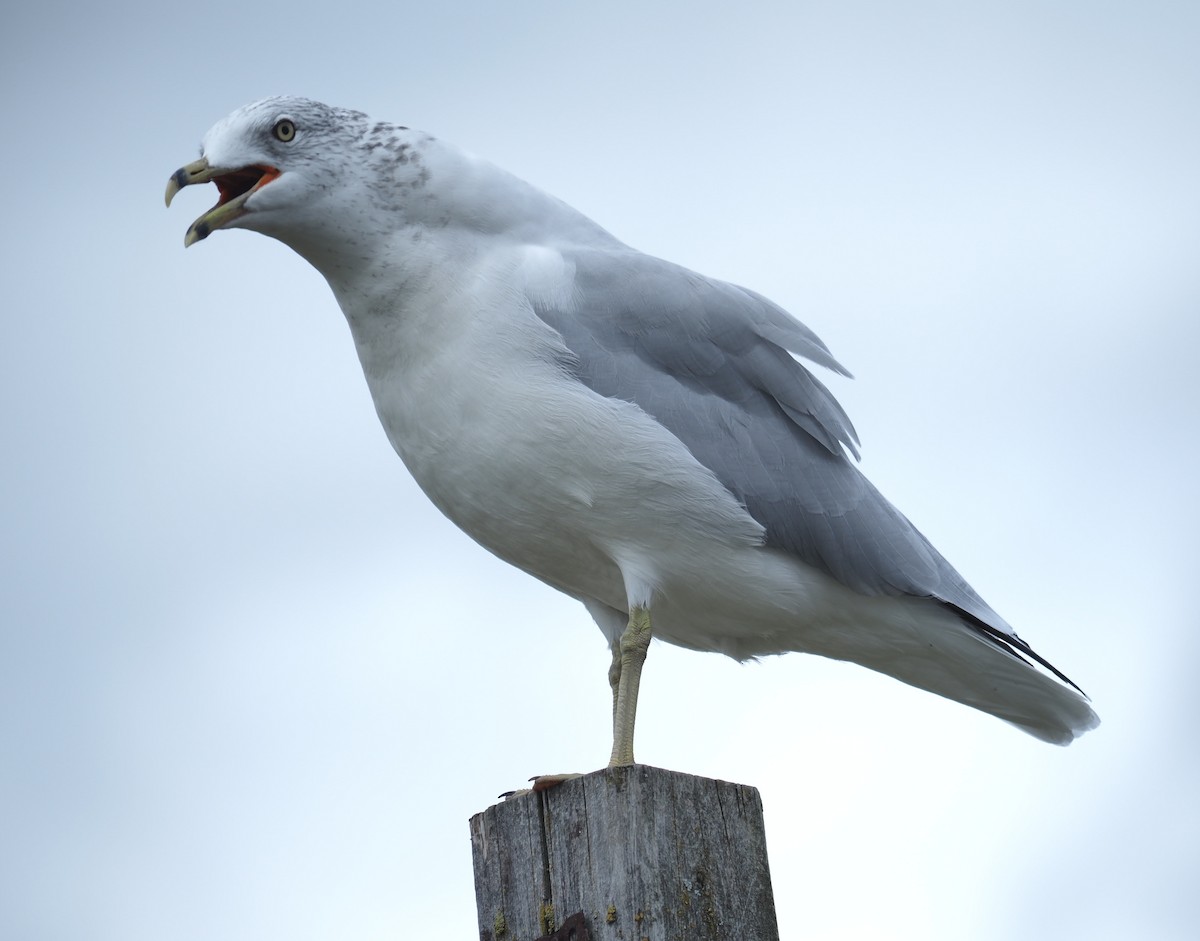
167, 97, 1099, 765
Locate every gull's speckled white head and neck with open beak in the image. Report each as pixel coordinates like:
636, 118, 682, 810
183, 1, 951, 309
167, 97, 618, 281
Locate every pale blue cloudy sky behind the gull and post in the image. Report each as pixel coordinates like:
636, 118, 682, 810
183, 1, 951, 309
0, 0, 1200, 941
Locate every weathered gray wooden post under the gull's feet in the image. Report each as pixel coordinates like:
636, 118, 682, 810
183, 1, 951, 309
470, 765, 779, 941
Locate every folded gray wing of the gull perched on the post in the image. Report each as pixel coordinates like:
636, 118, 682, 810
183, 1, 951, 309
534, 248, 1025, 633
